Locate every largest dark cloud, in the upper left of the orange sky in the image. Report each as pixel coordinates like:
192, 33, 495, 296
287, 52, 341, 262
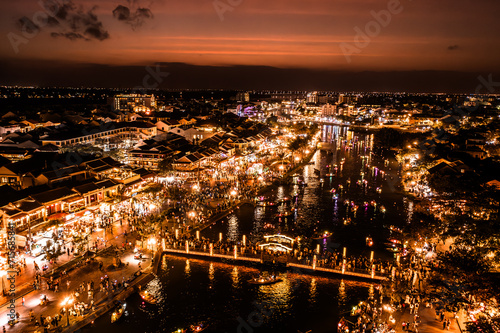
18, 0, 109, 41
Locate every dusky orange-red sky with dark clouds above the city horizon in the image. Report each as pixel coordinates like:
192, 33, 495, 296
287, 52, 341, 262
0, 0, 500, 92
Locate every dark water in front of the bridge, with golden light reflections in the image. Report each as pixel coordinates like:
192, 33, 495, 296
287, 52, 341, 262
85, 256, 374, 333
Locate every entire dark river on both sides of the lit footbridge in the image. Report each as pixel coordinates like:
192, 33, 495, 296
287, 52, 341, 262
86, 126, 412, 333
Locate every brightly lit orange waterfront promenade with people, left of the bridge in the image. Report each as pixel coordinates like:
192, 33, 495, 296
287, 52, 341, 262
0, 222, 152, 333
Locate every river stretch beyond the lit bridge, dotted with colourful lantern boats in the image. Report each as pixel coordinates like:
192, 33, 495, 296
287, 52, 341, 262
202, 126, 413, 259
